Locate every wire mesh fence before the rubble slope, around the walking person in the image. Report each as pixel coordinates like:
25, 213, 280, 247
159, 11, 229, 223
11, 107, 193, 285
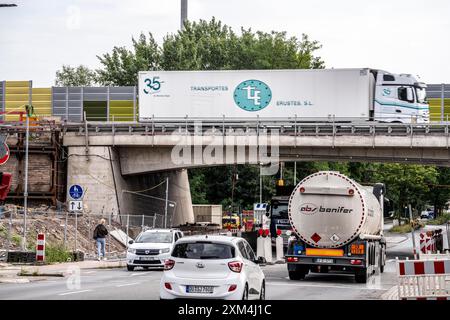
0, 208, 171, 259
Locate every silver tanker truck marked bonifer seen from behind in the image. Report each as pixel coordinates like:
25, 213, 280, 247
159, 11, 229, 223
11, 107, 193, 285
285, 171, 386, 283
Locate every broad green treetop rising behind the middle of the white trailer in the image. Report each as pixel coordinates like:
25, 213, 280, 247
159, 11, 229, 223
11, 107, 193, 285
161, 18, 324, 70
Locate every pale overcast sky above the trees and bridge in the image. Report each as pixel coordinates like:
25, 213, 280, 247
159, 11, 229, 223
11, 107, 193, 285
0, 0, 450, 87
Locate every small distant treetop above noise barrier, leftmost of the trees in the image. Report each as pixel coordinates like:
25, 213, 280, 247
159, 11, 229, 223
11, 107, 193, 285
55, 65, 96, 87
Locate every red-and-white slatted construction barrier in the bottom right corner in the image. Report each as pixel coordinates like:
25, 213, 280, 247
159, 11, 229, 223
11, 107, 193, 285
397, 259, 450, 300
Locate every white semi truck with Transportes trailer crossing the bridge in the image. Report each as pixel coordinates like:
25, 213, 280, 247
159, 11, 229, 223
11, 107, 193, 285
139, 68, 429, 123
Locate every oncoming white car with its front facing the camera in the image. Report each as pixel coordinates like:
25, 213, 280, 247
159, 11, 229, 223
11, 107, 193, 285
127, 229, 183, 271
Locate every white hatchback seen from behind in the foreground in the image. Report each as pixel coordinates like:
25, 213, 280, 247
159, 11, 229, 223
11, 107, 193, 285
160, 236, 266, 300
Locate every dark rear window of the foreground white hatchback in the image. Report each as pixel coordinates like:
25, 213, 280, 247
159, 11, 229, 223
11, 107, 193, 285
172, 242, 235, 259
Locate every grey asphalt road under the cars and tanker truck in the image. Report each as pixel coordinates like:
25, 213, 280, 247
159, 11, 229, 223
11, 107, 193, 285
0, 222, 436, 300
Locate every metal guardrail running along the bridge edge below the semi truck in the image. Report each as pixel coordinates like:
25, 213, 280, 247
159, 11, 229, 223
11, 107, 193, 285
61, 117, 450, 136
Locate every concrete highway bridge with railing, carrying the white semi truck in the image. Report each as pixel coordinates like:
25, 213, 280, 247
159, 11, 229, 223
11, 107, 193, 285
62, 118, 450, 225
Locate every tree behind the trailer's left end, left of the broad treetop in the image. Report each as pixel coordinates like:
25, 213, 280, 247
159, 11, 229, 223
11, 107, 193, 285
97, 33, 161, 86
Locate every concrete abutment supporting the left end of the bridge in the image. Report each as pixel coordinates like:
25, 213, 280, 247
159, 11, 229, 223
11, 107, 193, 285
67, 146, 194, 227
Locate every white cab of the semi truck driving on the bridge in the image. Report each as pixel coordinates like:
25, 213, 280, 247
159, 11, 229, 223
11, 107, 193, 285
371, 70, 430, 124
